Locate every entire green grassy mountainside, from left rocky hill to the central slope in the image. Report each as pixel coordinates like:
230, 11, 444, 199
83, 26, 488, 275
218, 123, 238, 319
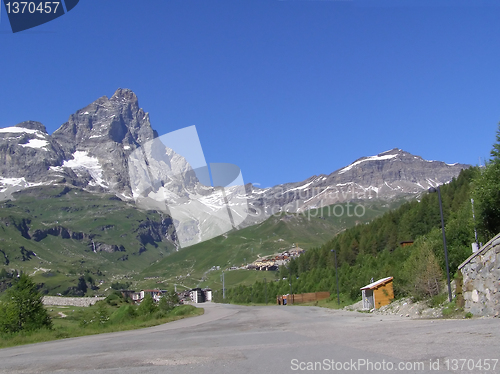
0, 186, 401, 296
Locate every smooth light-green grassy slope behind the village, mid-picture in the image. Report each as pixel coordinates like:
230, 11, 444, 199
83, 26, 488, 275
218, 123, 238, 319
142, 201, 402, 288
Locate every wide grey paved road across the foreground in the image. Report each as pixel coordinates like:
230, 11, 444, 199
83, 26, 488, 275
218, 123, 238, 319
0, 303, 500, 374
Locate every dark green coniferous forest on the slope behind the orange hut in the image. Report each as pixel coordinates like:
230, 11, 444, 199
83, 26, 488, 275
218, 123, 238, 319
215, 127, 500, 304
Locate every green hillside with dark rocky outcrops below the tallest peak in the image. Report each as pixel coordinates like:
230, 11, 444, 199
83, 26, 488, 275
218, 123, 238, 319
0, 186, 177, 294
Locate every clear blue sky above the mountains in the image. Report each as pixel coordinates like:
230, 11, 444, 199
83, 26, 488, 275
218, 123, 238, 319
0, 0, 500, 186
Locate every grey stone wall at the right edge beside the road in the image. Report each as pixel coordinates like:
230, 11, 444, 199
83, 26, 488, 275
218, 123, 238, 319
458, 234, 500, 317
